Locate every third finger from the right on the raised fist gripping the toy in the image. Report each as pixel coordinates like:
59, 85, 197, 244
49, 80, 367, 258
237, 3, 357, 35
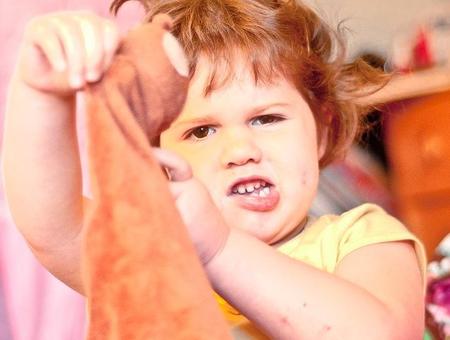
51, 16, 86, 89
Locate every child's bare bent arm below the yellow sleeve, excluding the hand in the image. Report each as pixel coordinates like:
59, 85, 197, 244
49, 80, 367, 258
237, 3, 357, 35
207, 230, 424, 339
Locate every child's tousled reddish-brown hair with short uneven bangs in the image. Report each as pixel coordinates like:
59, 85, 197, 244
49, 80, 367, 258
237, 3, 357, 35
111, 0, 386, 167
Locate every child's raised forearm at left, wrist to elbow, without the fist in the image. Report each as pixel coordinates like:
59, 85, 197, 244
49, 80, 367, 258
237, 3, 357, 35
2, 76, 82, 290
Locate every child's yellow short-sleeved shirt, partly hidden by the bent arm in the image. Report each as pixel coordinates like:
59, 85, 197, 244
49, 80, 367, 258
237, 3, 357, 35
218, 204, 426, 340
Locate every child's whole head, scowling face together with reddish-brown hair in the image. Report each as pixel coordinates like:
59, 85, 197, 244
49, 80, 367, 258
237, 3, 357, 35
112, 0, 384, 244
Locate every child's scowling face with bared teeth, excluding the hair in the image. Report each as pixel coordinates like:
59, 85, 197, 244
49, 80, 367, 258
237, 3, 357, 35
161, 60, 319, 244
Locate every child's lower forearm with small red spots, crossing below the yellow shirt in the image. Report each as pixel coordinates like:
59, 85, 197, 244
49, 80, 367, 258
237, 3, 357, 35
207, 231, 400, 339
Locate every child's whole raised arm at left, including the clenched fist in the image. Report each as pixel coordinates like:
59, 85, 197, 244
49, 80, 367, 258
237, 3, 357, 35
3, 12, 119, 291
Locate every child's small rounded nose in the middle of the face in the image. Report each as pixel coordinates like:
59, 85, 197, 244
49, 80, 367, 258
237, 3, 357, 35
220, 129, 262, 168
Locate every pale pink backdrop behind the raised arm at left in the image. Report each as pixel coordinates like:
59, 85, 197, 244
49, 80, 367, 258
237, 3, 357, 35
0, 0, 143, 340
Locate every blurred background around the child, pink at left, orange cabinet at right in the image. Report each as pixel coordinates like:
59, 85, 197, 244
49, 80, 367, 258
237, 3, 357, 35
0, 0, 450, 340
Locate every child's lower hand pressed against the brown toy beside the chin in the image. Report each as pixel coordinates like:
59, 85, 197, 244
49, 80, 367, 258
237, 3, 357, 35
153, 148, 230, 265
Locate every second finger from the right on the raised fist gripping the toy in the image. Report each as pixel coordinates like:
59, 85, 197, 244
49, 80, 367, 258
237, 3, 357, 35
74, 14, 105, 82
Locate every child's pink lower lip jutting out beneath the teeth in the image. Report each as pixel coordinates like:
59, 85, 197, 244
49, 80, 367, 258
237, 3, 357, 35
230, 186, 280, 211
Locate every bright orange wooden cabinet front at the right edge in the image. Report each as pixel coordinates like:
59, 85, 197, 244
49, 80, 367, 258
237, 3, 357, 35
385, 92, 450, 258
